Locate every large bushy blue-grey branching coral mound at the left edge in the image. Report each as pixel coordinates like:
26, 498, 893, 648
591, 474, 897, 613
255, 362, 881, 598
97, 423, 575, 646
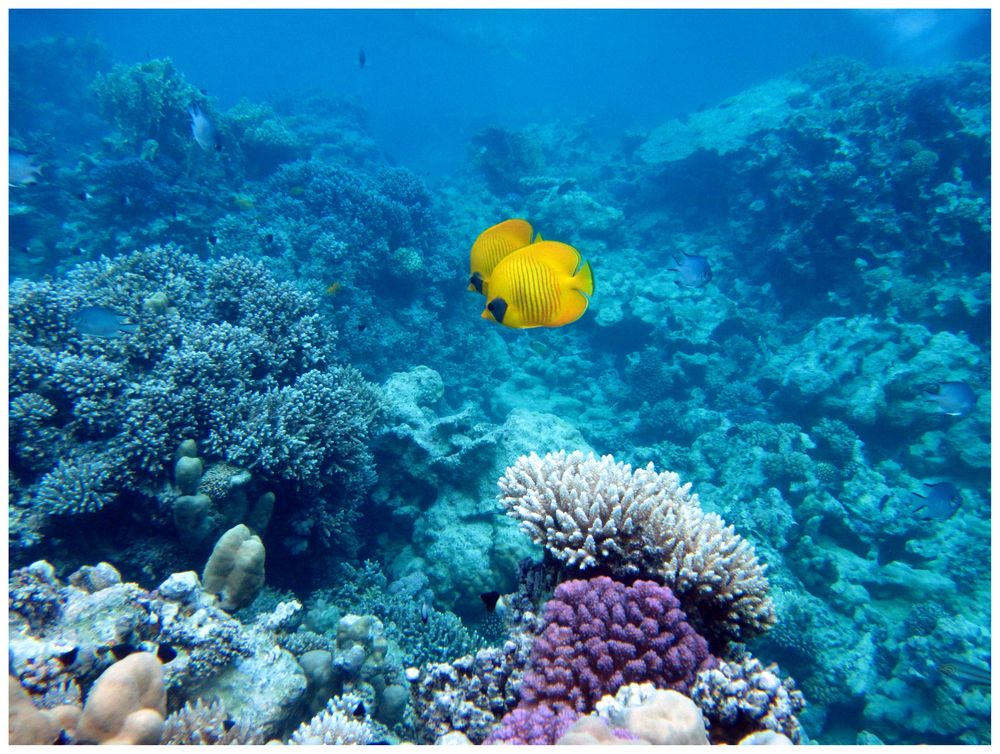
10, 248, 379, 566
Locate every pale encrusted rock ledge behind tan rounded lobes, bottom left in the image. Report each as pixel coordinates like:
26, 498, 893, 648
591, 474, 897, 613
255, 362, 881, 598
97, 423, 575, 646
10, 562, 306, 735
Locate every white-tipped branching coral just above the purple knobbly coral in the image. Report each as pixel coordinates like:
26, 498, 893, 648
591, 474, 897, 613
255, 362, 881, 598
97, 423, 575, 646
498, 451, 775, 640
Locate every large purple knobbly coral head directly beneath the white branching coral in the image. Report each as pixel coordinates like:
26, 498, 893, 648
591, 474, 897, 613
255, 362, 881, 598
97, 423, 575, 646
521, 576, 716, 713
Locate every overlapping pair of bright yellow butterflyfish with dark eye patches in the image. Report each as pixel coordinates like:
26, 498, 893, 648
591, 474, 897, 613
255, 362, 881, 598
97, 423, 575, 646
469, 218, 594, 329
